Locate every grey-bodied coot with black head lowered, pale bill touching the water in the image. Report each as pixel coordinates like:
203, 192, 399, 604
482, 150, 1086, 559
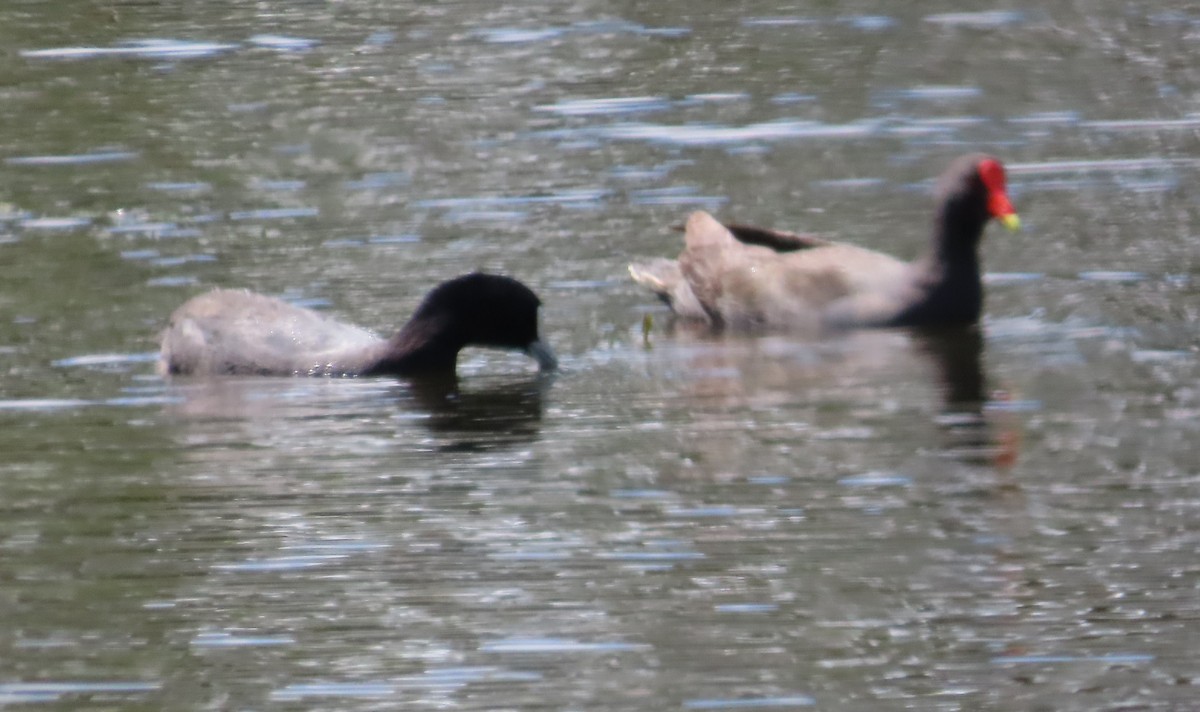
158, 273, 557, 376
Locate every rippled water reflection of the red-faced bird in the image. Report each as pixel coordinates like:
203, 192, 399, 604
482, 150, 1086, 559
646, 319, 1019, 468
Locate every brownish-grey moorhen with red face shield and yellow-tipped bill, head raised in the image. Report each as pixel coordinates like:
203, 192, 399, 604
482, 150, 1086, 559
629, 154, 1020, 331
